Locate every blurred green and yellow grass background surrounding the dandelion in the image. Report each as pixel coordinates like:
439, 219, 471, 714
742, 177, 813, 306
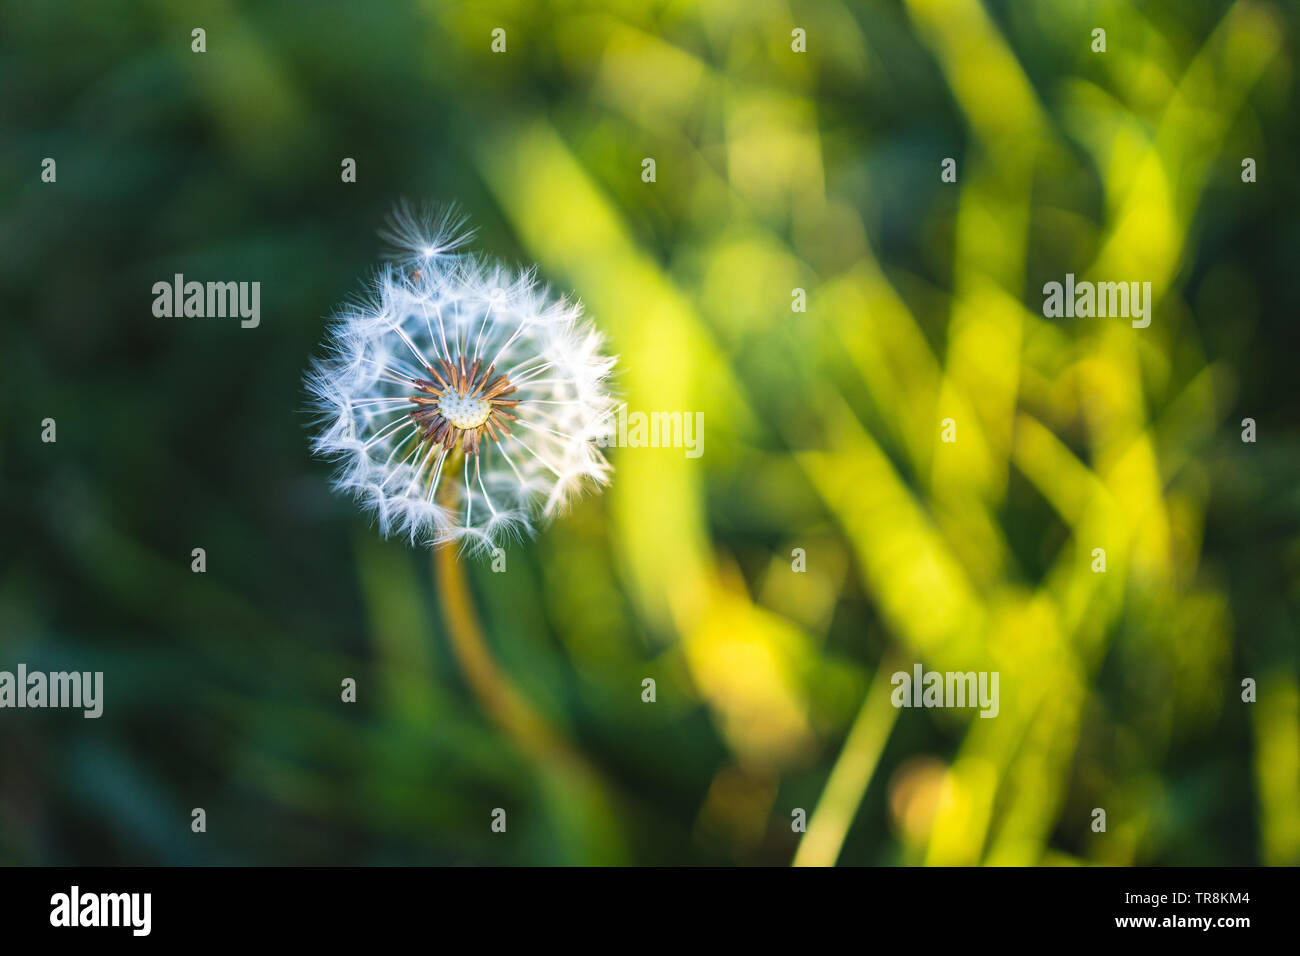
0, 0, 1300, 865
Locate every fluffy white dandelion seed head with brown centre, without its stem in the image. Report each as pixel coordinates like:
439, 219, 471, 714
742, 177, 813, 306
308, 206, 614, 551
